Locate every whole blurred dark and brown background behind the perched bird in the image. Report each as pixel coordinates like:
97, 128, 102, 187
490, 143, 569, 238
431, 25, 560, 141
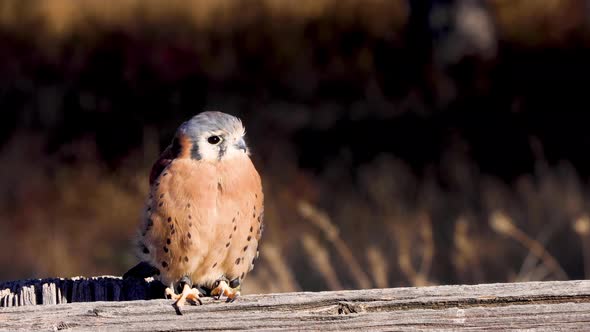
0, 0, 590, 293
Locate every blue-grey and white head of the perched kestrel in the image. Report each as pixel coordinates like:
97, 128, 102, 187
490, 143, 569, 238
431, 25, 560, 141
172, 112, 249, 161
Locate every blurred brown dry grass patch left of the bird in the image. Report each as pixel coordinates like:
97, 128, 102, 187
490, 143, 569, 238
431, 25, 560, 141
0, 135, 147, 278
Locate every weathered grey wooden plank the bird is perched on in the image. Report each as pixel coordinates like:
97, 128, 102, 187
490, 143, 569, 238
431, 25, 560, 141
0, 281, 590, 331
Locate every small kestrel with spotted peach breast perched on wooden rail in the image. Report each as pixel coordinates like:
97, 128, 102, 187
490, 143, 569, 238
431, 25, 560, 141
136, 111, 264, 308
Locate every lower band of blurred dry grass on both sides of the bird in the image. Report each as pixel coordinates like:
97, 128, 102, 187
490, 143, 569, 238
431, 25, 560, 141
0, 128, 589, 292
